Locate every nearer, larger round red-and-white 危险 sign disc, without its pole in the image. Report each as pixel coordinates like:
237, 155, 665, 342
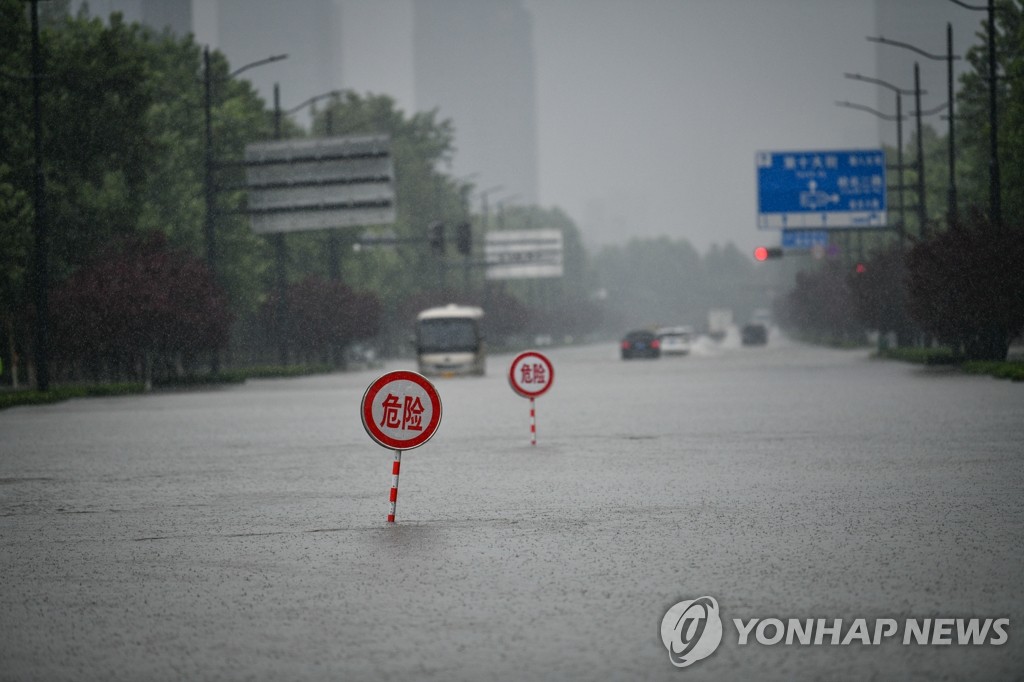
359, 370, 441, 450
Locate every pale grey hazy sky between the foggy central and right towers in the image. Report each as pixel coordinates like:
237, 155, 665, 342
516, 0, 879, 251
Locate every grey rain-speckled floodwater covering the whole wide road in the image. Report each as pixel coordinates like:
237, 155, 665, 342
0, 340, 1024, 680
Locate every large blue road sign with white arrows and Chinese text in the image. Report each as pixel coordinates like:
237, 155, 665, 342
757, 150, 886, 229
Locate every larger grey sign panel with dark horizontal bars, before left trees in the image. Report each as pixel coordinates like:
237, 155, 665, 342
244, 135, 395, 233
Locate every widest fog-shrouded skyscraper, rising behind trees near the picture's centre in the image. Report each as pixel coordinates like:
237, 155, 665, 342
413, 0, 538, 204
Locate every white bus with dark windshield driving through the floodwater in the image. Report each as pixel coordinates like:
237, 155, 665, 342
416, 303, 486, 377
